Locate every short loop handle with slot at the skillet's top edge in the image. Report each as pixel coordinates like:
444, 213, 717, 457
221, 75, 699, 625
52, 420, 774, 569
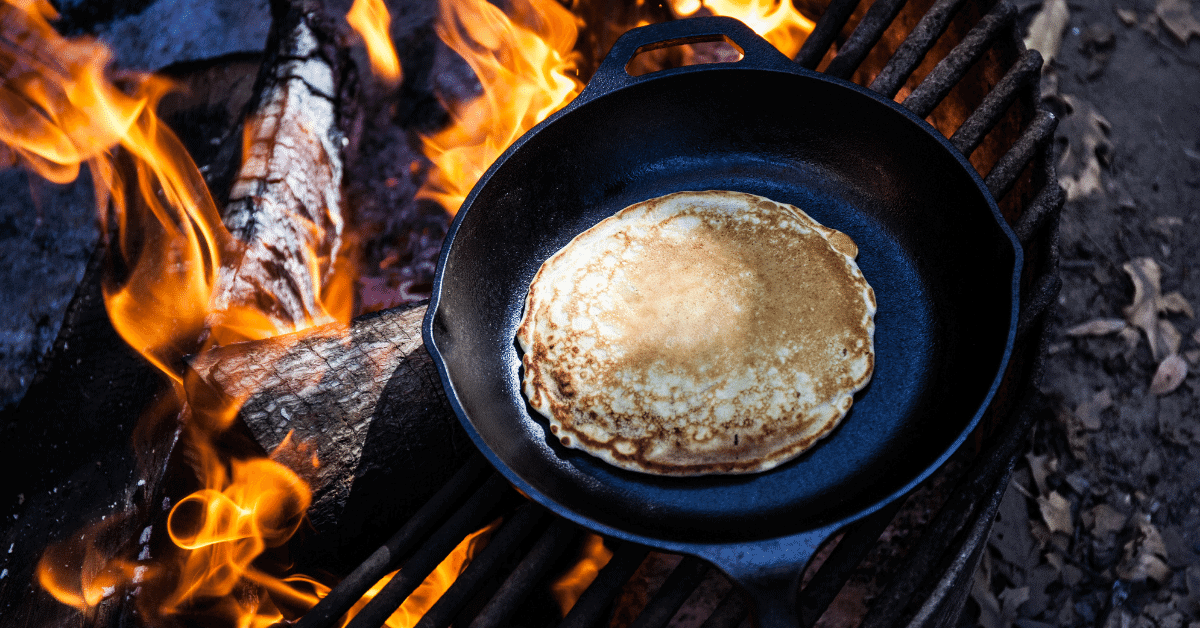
575, 16, 799, 102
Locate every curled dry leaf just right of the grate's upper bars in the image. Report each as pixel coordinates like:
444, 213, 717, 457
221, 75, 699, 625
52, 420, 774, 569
1058, 95, 1112, 201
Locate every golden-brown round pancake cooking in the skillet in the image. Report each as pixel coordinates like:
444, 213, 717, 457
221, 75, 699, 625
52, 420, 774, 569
517, 191, 876, 476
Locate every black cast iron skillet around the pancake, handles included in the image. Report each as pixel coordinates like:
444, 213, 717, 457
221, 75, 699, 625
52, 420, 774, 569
424, 18, 1021, 624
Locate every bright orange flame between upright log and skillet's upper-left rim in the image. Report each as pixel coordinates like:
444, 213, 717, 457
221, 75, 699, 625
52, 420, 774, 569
416, 0, 583, 214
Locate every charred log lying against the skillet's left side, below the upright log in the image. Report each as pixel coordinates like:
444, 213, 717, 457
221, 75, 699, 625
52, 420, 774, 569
187, 304, 472, 567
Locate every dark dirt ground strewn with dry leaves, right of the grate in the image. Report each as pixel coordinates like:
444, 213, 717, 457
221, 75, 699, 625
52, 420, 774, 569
964, 0, 1200, 628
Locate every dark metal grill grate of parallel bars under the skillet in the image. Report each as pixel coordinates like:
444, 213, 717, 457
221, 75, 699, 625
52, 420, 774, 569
296, 0, 1064, 628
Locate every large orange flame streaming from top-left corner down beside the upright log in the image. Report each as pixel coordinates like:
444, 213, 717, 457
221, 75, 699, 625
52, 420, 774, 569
0, 0, 232, 381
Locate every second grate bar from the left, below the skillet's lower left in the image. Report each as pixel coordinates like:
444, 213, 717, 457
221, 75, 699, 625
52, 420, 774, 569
347, 473, 510, 628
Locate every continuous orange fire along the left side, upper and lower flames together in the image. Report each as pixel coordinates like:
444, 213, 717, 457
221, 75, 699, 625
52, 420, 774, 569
0, 0, 348, 627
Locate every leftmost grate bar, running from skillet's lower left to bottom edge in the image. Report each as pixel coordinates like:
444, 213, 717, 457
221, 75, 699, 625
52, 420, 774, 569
296, 454, 487, 628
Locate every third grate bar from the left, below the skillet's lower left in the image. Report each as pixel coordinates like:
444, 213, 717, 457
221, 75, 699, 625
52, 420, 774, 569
416, 502, 550, 628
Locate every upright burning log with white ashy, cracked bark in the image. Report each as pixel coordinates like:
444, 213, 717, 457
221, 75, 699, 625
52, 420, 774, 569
212, 0, 354, 342
